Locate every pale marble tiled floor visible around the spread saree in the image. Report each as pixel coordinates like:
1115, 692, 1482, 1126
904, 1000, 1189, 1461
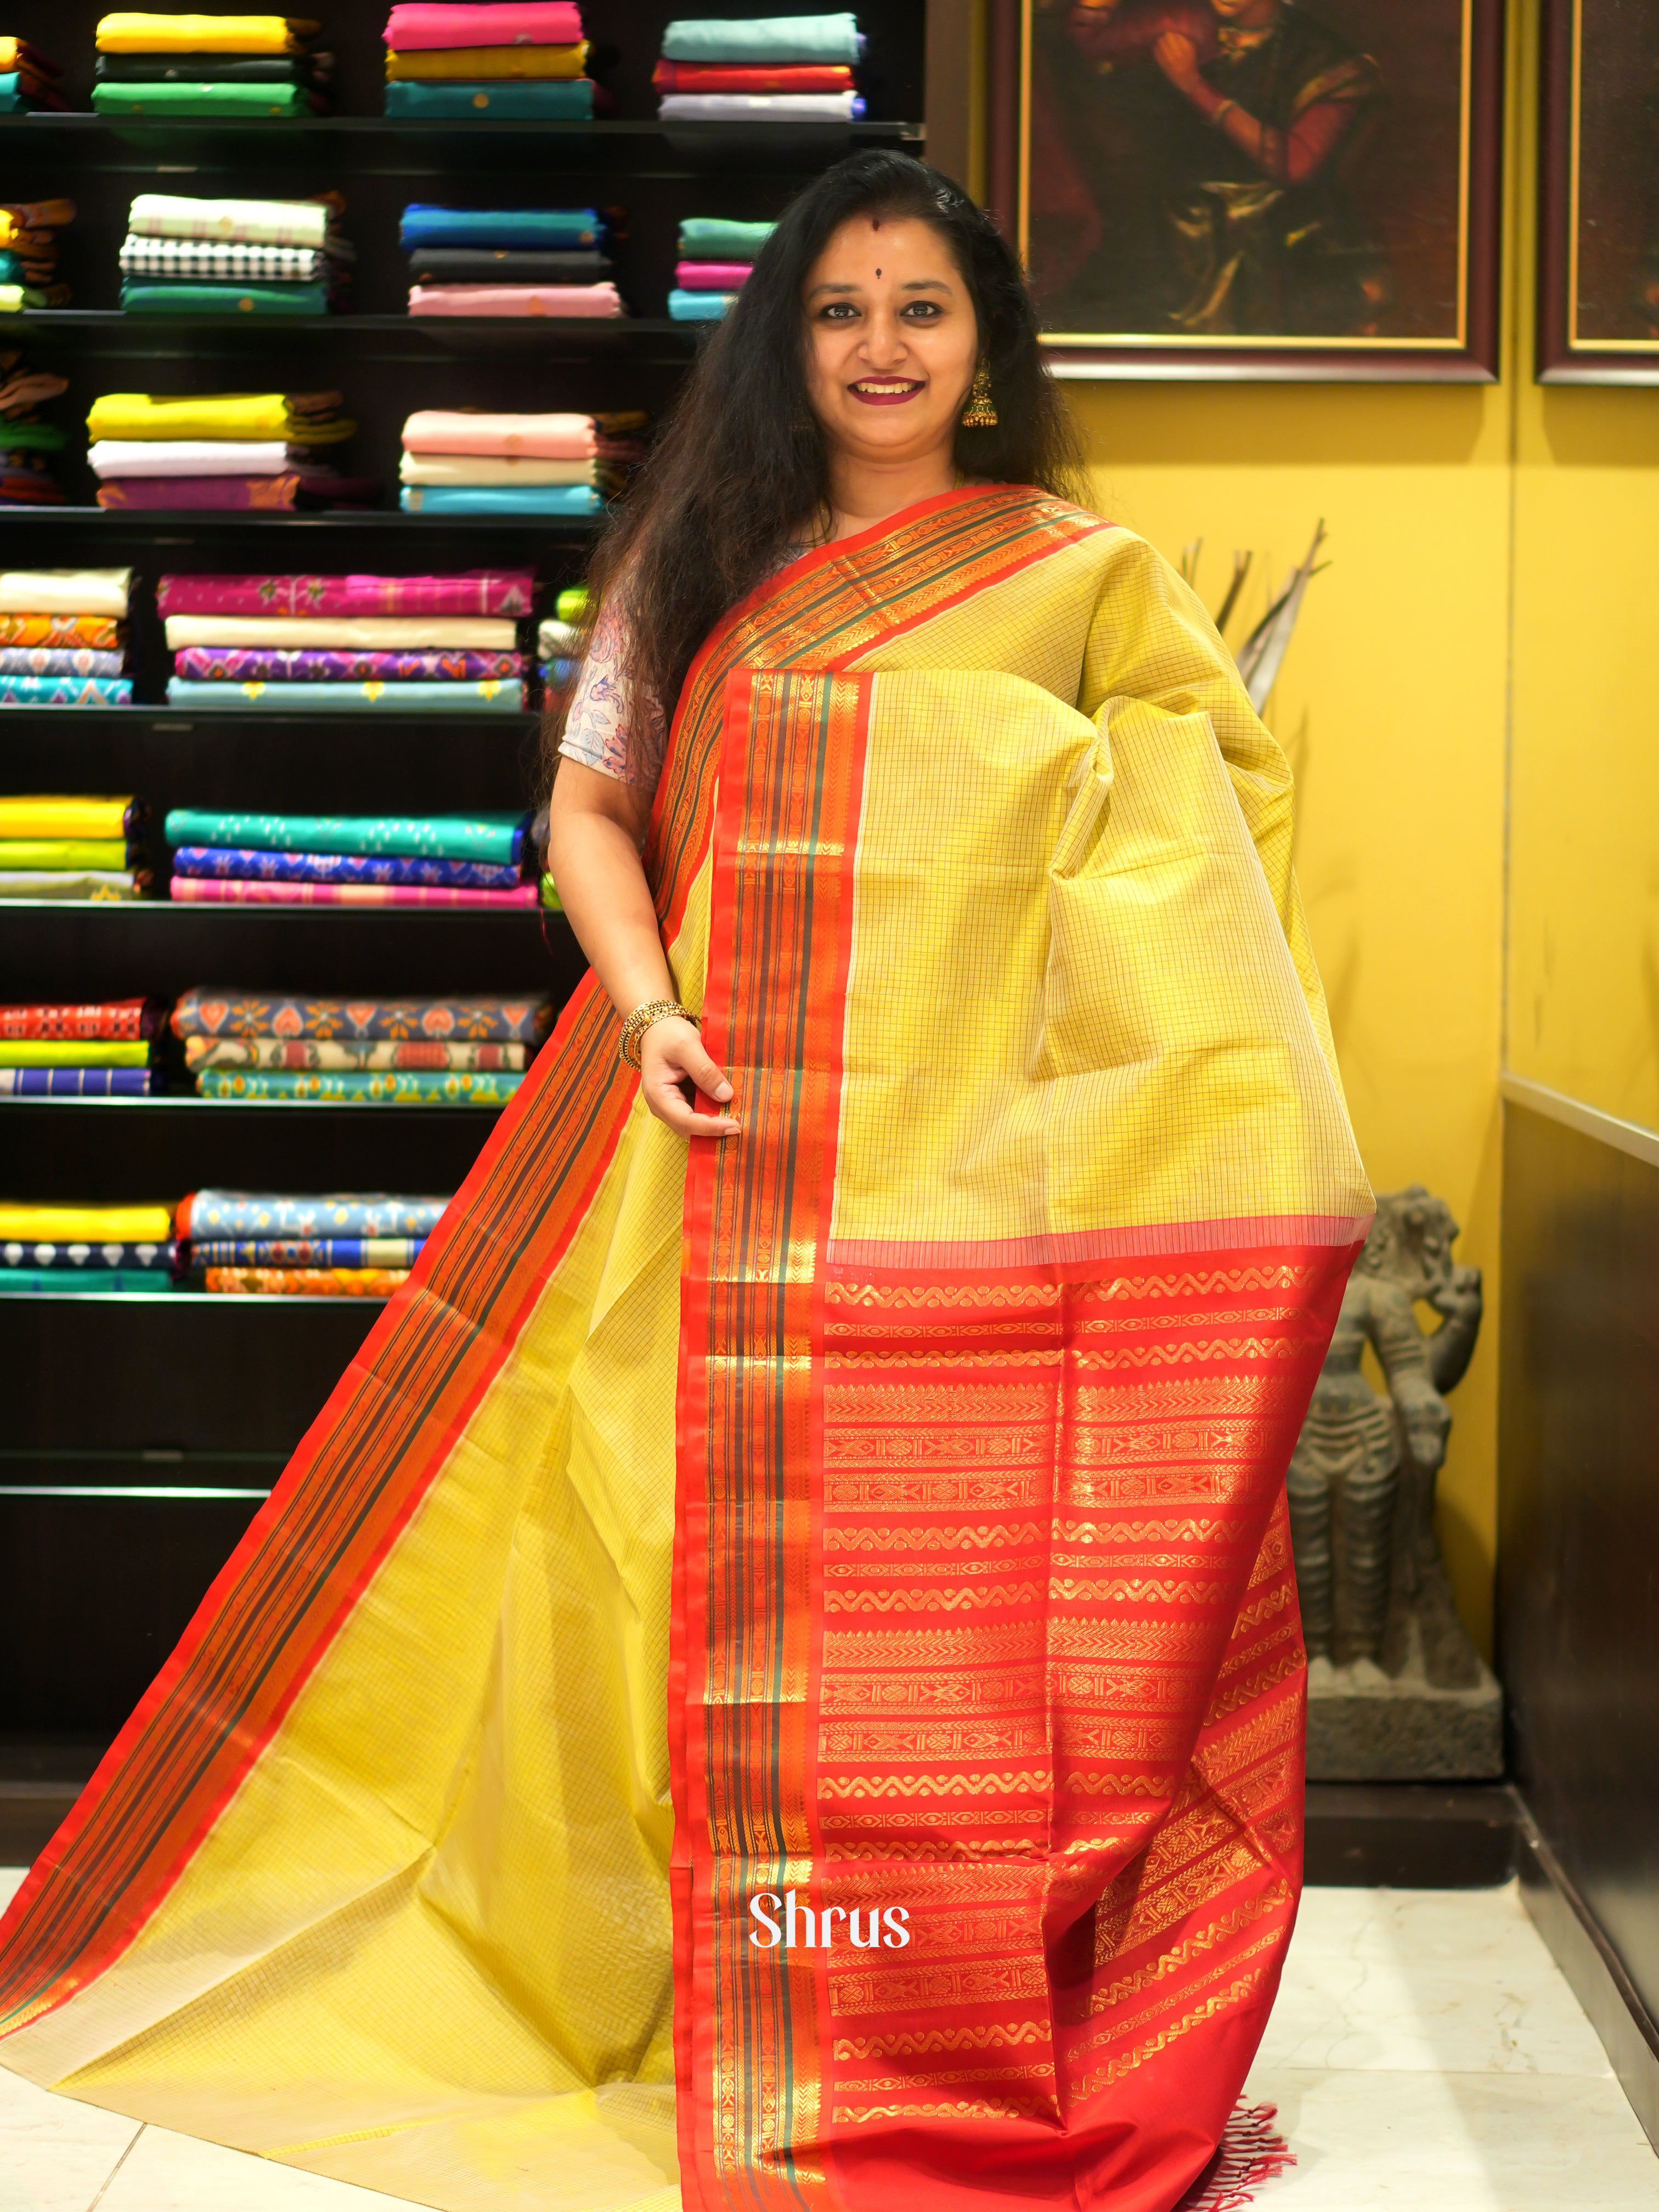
0, 1871, 1659, 2212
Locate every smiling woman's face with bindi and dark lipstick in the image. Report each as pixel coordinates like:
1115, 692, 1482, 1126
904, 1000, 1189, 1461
803, 215, 980, 462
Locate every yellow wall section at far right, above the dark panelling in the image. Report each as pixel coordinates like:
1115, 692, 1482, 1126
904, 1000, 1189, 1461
1509, 4, 1659, 1128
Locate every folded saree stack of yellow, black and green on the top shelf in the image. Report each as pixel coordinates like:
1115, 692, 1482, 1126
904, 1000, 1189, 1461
93, 13, 330, 122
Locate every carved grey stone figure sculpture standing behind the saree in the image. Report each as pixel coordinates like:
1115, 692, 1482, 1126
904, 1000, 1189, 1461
1290, 1183, 1504, 1781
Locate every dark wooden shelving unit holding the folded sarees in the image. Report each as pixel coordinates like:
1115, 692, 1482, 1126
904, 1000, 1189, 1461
0, 0, 940, 1743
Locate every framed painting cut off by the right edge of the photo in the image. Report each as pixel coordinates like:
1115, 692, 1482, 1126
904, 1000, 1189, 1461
1537, 0, 1659, 385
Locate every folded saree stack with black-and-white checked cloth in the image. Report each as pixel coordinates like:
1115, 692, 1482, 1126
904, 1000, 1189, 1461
122, 193, 352, 314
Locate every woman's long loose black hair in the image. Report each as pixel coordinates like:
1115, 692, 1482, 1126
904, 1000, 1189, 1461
553, 150, 1080, 752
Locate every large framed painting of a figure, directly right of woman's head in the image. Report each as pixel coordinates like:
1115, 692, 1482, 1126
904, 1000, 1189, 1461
989, 0, 1513, 383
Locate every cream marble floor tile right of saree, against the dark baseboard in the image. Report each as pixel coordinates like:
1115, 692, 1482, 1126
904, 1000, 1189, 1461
1259, 1882, 1610, 2077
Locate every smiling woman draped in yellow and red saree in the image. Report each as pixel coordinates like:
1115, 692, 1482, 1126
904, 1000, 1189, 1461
0, 155, 1369, 2212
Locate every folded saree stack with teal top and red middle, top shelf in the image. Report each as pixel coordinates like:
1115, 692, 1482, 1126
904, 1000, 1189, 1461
652, 15, 865, 124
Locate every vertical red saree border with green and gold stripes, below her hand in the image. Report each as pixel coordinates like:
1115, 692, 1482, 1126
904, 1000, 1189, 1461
673, 670, 872, 2212
